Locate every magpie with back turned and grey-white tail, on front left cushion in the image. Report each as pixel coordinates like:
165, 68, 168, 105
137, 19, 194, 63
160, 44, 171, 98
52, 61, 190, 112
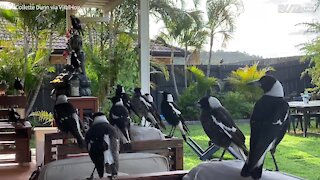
85, 112, 120, 179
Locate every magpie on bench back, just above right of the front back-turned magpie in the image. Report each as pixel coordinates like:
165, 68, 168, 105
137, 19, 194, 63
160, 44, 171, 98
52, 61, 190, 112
109, 96, 131, 143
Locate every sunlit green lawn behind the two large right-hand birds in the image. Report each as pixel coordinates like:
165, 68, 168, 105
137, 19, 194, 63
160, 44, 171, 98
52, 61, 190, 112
167, 124, 320, 180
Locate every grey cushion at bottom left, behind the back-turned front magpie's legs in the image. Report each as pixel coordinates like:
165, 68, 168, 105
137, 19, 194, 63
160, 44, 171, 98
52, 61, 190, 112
39, 153, 169, 180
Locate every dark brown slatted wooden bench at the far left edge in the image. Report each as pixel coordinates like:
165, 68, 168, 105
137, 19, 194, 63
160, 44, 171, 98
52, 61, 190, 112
0, 96, 32, 163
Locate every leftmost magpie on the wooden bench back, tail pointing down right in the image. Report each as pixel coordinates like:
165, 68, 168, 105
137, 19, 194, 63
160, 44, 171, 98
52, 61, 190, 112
53, 94, 85, 148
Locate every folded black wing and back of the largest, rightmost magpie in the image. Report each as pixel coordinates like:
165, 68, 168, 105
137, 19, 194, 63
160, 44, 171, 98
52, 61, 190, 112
248, 98, 289, 169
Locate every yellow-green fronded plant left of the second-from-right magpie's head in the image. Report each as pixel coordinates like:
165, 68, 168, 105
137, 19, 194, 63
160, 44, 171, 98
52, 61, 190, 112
178, 66, 217, 120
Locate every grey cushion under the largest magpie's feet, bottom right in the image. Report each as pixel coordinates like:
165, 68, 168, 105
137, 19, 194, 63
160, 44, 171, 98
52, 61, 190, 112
183, 160, 300, 180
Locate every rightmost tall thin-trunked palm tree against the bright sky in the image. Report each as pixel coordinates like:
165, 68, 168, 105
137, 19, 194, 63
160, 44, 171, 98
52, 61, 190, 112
206, 0, 242, 77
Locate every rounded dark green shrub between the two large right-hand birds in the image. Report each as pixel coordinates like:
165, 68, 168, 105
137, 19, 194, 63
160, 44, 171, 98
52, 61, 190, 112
220, 91, 254, 119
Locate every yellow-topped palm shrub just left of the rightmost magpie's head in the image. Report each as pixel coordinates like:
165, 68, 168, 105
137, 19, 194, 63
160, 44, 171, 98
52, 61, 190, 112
227, 63, 274, 102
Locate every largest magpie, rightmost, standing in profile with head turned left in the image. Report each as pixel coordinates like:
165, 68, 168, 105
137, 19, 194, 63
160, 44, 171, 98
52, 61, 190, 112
241, 75, 289, 179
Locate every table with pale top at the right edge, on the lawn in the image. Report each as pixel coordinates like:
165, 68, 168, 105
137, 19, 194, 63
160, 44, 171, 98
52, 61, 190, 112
288, 100, 320, 137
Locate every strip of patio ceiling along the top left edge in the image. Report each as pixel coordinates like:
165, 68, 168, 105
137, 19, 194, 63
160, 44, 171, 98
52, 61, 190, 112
0, 0, 123, 11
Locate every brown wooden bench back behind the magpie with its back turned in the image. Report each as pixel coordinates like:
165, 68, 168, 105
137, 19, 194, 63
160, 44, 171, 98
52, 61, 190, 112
44, 133, 183, 170
